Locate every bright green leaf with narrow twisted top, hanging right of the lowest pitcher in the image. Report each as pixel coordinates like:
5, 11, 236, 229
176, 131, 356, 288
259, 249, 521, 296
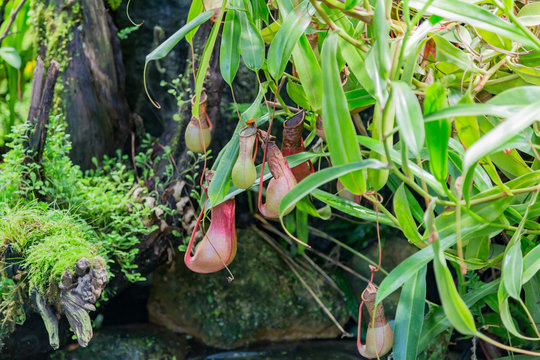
425, 201, 476, 335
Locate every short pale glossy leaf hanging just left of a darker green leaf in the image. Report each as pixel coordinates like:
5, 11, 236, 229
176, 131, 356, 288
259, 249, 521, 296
392, 81, 425, 156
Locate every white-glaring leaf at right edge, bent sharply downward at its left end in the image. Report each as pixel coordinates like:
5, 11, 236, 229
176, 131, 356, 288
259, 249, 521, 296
463, 102, 540, 201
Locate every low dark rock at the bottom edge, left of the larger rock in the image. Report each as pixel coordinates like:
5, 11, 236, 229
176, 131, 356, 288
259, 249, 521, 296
51, 325, 187, 360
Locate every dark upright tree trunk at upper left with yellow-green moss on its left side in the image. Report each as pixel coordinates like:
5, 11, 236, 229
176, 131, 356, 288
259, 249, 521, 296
37, 0, 131, 169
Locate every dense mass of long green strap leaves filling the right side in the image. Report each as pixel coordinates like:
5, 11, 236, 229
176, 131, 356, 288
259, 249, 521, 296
147, 0, 540, 359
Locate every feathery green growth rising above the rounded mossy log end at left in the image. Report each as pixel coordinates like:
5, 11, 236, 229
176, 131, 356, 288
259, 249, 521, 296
0, 121, 160, 281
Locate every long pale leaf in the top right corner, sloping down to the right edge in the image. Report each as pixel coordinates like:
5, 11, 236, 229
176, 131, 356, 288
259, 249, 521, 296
409, 0, 536, 46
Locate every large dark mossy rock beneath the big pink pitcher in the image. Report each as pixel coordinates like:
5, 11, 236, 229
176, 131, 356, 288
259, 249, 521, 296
148, 230, 347, 348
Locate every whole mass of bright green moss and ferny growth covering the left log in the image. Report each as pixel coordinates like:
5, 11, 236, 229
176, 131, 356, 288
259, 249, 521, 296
0, 117, 173, 338
